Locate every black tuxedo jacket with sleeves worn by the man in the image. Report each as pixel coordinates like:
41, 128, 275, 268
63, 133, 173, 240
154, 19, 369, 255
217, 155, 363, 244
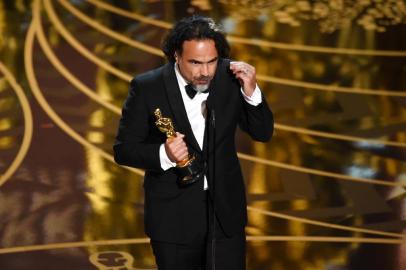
114, 59, 273, 243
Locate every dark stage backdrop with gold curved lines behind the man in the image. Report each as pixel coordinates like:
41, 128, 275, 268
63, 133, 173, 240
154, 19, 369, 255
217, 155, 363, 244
0, 0, 406, 270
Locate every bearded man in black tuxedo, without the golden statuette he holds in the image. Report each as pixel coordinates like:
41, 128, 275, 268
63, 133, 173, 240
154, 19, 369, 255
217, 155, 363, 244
114, 16, 273, 270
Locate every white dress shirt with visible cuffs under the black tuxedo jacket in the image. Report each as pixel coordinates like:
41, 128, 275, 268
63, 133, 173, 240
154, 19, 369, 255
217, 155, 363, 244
159, 63, 262, 189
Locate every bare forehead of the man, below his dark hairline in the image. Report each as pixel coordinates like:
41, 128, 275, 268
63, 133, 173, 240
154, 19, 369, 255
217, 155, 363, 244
182, 39, 218, 61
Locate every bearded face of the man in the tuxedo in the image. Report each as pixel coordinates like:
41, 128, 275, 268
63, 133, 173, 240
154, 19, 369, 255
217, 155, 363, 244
175, 39, 218, 91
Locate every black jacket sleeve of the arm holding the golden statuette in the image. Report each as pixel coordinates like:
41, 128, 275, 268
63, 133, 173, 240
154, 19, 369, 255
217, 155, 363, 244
113, 79, 162, 171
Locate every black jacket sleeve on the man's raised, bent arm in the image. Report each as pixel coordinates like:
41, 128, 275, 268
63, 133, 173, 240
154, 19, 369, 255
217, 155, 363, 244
239, 94, 274, 142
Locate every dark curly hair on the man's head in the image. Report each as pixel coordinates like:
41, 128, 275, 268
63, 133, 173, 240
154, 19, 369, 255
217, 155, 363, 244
162, 15, 230, 63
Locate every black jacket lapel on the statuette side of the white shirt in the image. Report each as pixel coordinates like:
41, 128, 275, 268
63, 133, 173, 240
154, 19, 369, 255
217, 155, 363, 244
163, 63, 201, 152
